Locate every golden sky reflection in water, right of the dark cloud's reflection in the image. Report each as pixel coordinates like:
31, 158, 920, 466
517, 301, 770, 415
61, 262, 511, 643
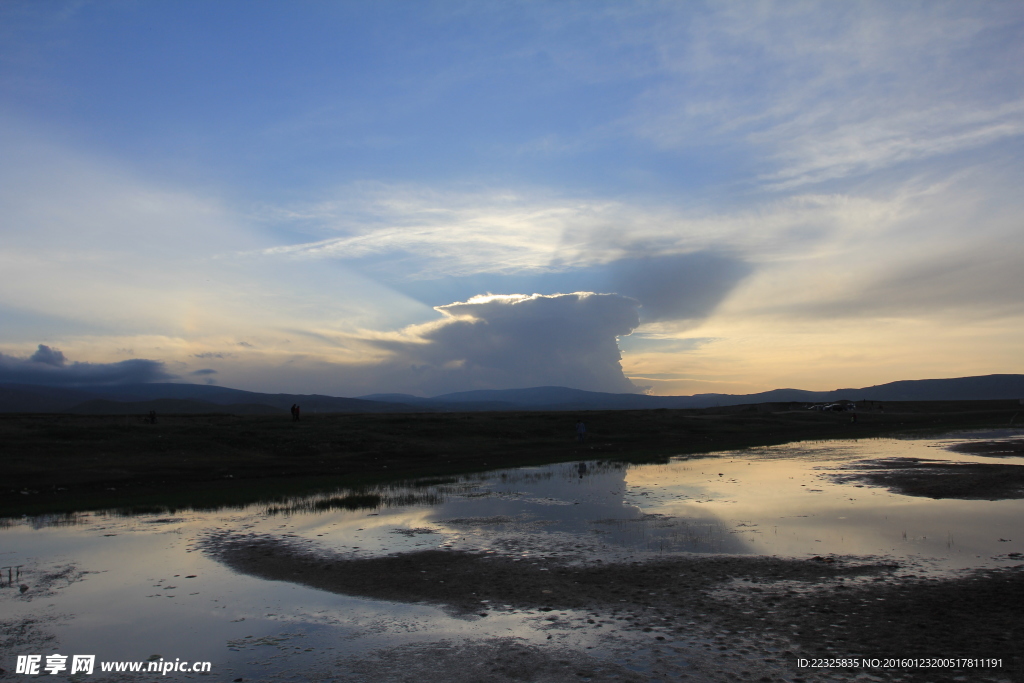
614, 439, 1024, 568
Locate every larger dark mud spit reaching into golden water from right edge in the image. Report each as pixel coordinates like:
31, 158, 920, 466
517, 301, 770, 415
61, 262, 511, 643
831, 454, 1024, 501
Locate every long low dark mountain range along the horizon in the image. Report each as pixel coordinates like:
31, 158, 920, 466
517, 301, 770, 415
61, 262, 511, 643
0, 375, 1024, 415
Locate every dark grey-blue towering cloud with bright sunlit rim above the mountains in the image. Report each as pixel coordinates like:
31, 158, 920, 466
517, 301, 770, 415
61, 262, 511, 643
372, 292, 639, 394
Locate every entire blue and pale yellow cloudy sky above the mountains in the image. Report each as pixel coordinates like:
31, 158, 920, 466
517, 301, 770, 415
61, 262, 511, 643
0, 0, 1024, 396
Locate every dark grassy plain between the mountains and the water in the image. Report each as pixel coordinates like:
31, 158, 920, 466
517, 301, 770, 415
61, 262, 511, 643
0, 400, 1021, 517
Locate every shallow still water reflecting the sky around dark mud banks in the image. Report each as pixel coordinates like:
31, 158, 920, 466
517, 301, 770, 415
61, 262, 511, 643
0, 431, 1024, 681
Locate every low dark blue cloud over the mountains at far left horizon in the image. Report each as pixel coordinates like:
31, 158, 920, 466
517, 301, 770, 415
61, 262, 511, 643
0, 344, 174, 386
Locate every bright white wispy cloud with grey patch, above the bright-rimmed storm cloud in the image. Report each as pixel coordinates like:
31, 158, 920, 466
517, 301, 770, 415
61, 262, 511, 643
253, 184, 770, 322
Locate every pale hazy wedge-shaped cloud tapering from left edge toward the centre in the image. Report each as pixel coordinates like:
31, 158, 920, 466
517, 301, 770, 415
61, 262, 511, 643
0, 122, 432, 348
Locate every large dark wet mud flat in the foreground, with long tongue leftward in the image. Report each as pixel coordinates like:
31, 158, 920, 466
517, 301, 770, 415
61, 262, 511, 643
205, 535, 1024, 682
